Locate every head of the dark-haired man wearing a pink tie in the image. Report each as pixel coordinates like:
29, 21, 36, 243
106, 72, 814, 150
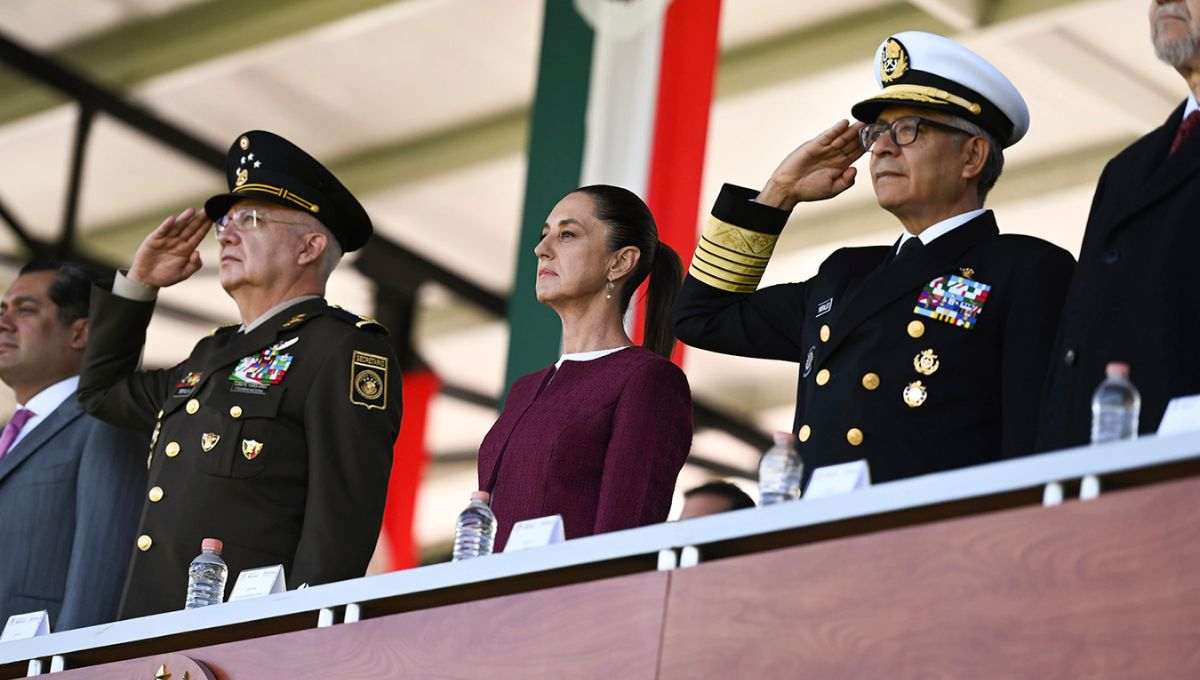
0, 261, 98, 403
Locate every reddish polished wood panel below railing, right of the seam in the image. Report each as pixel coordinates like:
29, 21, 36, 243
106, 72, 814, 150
660, 479, 1200, 680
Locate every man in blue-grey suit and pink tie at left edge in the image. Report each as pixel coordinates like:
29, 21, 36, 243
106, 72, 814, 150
0, 263, 149, 631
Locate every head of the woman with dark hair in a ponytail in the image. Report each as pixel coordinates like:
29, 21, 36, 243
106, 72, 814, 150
534, 185, 683, 356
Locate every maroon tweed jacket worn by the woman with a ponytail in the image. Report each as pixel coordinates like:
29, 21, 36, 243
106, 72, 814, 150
479, 347, 691, 552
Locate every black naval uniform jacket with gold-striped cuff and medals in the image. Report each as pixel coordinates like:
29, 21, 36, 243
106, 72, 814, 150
672, 185, 1073, 482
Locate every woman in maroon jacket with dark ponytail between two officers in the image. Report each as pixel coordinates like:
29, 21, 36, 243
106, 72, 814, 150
479, 185, 691, 552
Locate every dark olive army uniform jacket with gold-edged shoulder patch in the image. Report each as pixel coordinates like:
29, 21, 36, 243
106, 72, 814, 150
79, 288, 401, 618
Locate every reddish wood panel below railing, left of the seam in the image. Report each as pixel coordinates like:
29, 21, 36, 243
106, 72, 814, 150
55, 572, 668, 680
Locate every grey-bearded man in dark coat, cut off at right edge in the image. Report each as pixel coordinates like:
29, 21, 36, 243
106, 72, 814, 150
1039, 0, 1200, 450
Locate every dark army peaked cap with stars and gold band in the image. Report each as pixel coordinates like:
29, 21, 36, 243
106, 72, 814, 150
204, 130, 372, 253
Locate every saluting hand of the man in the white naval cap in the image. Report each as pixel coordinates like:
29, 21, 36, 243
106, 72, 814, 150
756, 120, 863, 210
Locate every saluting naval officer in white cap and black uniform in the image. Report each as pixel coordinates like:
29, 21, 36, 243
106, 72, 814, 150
672, 32, 1073, 482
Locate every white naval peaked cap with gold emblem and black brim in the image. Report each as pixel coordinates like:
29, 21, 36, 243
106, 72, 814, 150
850, 31, 1030, 146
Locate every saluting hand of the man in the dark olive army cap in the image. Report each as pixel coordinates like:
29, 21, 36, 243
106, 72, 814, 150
128, 207, 212, 288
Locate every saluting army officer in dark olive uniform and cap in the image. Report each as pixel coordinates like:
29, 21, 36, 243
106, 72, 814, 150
79, 132, 401, 619
